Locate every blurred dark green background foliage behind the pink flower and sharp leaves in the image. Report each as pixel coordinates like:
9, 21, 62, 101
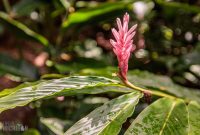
0, 0, 200, 134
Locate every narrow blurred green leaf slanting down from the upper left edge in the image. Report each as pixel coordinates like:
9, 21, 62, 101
0, 12, 49, 46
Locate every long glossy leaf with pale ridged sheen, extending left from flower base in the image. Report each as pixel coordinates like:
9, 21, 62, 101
0, 76, 132, 112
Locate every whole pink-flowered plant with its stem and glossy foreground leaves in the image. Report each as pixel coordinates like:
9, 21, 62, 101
0, 10, 200, 135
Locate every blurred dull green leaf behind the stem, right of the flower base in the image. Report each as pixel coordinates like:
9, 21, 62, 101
128, 70, 200, 102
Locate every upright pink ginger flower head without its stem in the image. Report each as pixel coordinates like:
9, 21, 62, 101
110, 13, 137, 81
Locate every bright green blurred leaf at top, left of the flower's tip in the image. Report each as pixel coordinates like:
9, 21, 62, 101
62, 2, 130, 29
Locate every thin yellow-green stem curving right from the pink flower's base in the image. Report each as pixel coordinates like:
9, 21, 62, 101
123, 80, 176, 99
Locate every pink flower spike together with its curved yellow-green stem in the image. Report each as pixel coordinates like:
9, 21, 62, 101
110, 13, 176, 100
